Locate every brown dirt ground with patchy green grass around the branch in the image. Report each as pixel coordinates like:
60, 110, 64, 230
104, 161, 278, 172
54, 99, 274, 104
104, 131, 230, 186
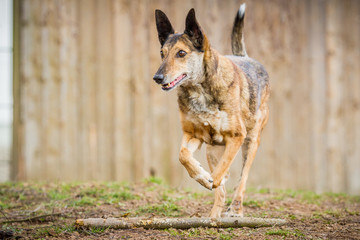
0, 178, 360, 239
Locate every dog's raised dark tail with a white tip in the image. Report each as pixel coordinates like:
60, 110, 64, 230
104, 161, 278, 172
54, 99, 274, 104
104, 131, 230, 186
231, 3, 247, 57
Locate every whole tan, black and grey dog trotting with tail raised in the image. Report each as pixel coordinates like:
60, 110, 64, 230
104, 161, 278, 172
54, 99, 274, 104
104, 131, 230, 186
154, 4, 269, 218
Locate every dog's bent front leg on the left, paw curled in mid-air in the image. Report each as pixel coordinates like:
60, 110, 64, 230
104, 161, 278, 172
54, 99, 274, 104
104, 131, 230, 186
179, 133, 213, 190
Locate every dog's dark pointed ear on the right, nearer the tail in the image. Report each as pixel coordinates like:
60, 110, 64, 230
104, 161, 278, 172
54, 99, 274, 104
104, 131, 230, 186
184, 8, 204, 50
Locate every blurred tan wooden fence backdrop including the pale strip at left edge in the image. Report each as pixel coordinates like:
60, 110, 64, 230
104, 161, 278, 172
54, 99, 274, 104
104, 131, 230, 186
0, 0, 360, 194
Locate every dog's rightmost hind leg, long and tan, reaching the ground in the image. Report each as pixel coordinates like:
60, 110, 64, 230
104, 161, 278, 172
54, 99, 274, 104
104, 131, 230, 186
224, 107, 269, 217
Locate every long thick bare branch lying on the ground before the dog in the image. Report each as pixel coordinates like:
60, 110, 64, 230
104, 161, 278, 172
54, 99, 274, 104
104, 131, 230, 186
75, 217, 286, 229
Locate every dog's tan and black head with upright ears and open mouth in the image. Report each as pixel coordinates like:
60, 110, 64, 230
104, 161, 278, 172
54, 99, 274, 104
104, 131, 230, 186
154, 9, 207, 91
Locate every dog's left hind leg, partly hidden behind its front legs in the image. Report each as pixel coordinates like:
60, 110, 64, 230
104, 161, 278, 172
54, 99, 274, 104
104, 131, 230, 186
206, 145, 229, 218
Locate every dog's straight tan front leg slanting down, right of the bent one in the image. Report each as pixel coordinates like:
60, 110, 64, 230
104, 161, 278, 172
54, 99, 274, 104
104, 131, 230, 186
211, 135, 244, 188
